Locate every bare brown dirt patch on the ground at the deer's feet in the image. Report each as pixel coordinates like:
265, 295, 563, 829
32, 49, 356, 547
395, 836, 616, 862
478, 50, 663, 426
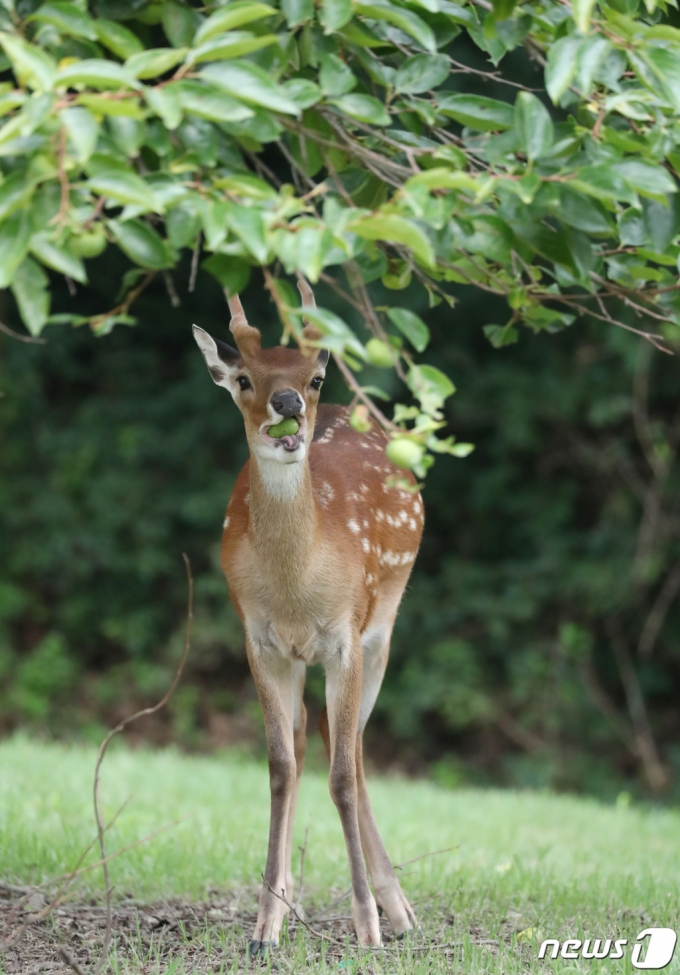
0, 884, 499, 975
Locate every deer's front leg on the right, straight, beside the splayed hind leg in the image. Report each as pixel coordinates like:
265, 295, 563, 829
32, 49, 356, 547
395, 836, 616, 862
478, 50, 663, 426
326, 635, 380, 948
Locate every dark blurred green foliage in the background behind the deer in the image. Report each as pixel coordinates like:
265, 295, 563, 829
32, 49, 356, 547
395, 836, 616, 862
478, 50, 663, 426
0, 242, 680, 800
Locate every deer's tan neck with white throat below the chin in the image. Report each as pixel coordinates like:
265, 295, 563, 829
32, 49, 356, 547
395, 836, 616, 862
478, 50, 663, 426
250, 456, 317, 588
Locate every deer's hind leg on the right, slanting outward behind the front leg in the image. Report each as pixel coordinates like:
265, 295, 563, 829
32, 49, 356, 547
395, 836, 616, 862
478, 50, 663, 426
356, 621, 416, 937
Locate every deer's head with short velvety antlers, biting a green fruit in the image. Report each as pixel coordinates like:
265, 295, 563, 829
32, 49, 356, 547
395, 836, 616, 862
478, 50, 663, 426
194, 281, 328, 464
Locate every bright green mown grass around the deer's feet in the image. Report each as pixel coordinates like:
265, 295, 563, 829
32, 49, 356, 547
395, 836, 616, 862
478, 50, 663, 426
0, 737, 680, 975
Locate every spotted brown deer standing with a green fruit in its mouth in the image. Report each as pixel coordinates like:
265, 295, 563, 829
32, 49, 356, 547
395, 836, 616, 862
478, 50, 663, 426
193, 279, 424, 957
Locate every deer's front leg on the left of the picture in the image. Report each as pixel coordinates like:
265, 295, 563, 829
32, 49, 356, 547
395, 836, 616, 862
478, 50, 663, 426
248, 643, 299, 954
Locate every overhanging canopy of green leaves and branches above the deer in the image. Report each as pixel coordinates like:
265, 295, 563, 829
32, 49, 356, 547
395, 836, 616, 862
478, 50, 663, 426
0, 0, 680, 475
